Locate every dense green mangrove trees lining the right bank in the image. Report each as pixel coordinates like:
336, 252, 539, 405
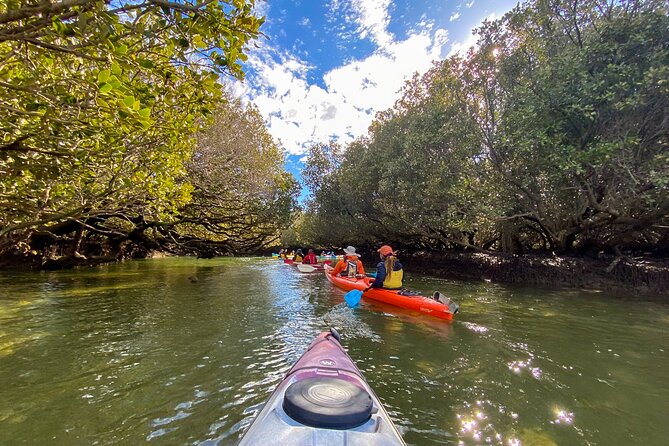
302, 0, 669, 253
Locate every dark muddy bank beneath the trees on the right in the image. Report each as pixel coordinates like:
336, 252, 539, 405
388, 251, 669, 301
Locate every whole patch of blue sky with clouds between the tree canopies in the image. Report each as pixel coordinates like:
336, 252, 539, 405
238, 0, 517, 197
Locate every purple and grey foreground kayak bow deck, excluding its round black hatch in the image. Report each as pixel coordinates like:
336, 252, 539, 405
238, 332, 405, 446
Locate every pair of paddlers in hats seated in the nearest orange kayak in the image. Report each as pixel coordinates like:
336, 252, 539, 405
332, 245, 404, 291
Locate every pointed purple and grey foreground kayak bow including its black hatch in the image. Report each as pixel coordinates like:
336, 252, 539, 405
238, 330, 405, 446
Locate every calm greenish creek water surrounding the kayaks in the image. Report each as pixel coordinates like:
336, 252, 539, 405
0, 258, 669, 446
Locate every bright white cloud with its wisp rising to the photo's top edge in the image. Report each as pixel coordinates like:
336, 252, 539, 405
238, 0, 508, 155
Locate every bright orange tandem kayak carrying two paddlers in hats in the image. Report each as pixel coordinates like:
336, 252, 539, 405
325, 266, 457, 321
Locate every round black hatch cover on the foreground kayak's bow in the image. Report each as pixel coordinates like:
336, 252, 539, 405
283, 377, 373, 429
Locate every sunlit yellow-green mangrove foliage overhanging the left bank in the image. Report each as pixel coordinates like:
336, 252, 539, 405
0, 0, 298, 266
